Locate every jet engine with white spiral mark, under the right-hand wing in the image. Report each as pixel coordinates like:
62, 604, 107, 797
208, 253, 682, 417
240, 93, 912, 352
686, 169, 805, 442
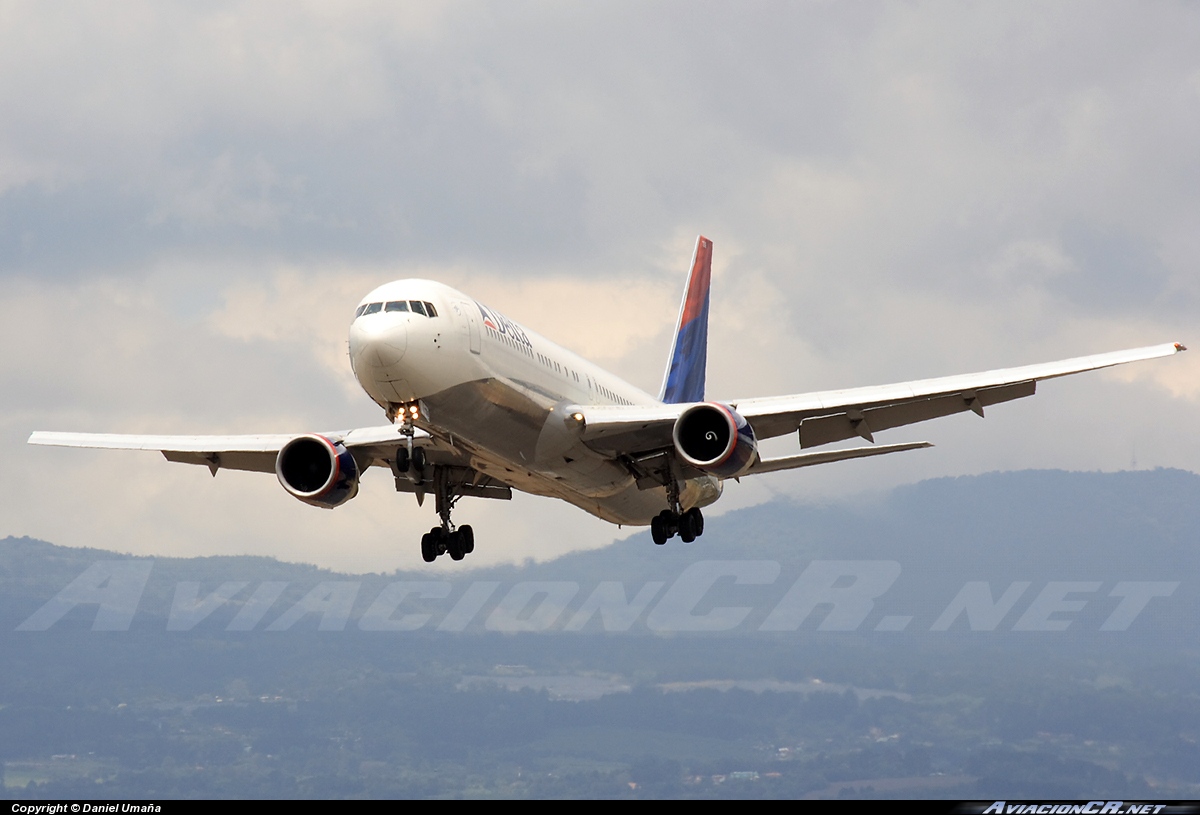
672, 402, 758, 478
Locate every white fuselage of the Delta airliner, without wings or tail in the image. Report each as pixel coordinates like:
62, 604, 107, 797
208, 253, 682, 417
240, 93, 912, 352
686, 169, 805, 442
349, 280, 721, 525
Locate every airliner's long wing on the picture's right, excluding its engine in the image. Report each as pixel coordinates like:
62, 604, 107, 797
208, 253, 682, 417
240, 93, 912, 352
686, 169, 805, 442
572, 342, 1186, 463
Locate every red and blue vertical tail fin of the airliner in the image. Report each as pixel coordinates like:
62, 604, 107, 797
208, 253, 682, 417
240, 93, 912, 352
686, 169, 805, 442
659, 235, 713, 404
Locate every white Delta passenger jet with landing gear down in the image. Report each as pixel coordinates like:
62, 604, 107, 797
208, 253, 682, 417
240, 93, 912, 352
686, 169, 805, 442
29, 235, 1186, 563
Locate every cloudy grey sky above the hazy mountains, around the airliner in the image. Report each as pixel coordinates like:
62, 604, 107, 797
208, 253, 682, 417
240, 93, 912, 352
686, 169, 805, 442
0, 0, 1200, 571
